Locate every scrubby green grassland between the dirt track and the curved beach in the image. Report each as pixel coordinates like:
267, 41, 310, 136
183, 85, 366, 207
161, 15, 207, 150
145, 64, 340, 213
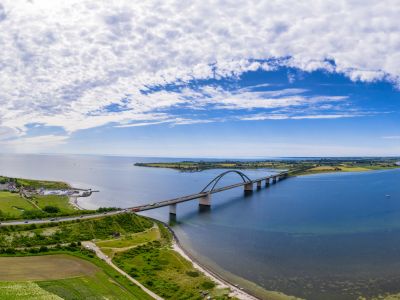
111, 224, 230, 299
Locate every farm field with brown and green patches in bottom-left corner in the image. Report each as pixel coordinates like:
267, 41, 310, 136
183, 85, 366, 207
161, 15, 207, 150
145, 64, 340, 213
0, 255, 150, 300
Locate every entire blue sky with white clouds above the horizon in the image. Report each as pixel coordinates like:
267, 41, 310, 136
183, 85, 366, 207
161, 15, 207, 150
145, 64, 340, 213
0, 0, 400, 158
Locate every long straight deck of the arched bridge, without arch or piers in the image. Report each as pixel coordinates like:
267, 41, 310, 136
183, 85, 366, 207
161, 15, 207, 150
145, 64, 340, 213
130, 172, 287, 212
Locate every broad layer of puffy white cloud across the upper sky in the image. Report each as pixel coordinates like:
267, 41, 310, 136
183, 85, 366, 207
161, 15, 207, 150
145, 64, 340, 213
0, 0, 400, 139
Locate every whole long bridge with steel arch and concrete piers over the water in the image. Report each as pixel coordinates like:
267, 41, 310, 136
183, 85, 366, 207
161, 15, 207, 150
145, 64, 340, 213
130, 170, 288, 216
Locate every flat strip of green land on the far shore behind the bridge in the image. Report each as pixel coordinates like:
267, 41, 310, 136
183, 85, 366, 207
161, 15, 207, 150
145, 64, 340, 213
135, 158, 400, 175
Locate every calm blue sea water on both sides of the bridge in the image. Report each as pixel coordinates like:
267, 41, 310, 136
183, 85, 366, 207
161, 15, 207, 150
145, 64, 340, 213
0, 155, 400, 299
